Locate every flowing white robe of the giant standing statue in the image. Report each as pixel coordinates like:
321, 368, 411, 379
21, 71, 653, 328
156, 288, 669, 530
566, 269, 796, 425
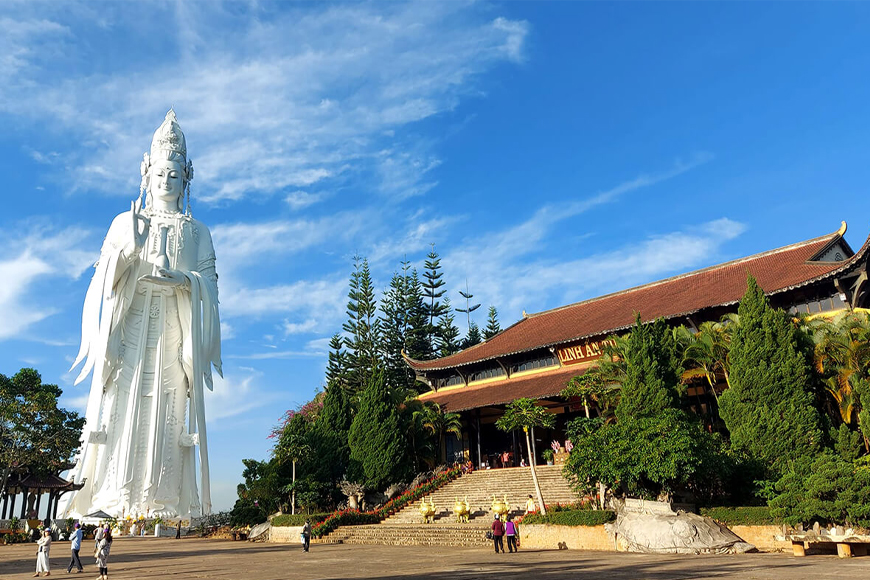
65, 212, 221, 516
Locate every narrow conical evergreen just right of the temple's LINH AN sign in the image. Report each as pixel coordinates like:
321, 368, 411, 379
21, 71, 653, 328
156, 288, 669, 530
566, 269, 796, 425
616, 315, 680, 421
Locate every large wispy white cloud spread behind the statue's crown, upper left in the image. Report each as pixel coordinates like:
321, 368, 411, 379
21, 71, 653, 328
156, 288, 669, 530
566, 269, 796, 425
0, 2, 528, 206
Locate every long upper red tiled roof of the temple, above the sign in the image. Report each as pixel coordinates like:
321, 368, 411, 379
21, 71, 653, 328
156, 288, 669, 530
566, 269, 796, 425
406, 222, 870, 371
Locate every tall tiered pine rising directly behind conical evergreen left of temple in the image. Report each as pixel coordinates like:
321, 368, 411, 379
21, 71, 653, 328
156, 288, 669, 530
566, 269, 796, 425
343, 256, 380, 391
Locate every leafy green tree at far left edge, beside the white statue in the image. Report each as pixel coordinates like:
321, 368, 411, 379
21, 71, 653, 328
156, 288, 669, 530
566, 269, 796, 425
0, 368, 85, 495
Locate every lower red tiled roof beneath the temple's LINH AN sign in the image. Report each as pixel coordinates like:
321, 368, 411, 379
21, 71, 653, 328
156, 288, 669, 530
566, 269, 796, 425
420, 365, 589, 413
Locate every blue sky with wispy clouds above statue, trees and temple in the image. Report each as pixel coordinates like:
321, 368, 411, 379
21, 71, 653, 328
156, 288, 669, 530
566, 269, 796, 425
0, 2, 870, 509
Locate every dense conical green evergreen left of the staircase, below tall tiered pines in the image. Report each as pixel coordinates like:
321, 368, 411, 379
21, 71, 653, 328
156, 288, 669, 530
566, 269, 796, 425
348, 371, 410, 490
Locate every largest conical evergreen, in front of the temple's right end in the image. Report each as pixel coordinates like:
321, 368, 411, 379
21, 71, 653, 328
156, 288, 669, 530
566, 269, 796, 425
719, 276, 822, 476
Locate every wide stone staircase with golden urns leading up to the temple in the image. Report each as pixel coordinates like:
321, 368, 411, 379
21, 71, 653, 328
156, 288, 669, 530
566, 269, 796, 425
317, 465, 579, 546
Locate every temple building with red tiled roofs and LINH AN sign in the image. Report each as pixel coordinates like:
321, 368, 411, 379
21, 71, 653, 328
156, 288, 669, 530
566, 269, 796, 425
406, 222, 870, 467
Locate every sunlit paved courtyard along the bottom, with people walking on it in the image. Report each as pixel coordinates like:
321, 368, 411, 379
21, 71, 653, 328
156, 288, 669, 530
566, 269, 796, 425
0, 538, 870, 580
